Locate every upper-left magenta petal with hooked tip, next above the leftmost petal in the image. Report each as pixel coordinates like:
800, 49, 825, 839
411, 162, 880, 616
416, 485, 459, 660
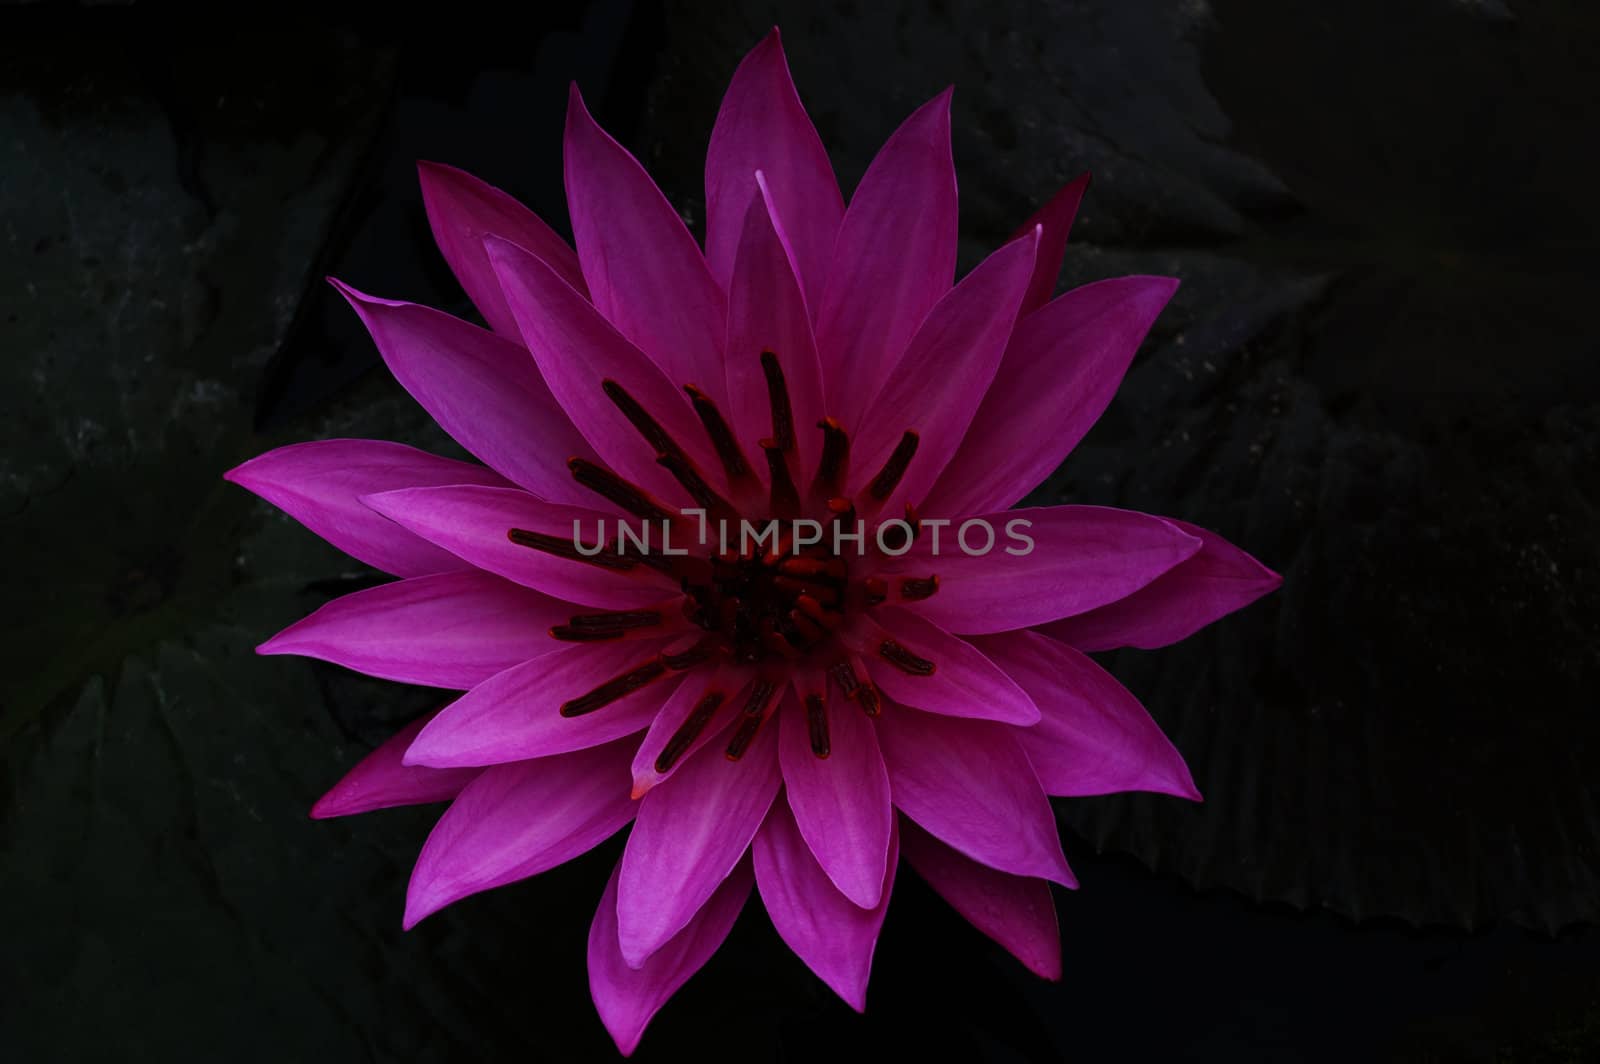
333, 282, 595, 506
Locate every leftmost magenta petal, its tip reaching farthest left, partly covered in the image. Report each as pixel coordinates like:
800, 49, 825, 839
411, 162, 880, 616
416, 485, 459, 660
222, 440, 506, 576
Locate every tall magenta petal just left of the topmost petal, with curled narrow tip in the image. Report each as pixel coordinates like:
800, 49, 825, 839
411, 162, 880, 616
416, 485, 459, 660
565, 85, 726, 400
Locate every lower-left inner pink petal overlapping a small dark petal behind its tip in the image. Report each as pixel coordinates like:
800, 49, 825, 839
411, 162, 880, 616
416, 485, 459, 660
405, 640, 678, 768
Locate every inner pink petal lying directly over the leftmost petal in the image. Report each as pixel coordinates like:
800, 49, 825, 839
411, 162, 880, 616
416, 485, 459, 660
363, 486, 674, 610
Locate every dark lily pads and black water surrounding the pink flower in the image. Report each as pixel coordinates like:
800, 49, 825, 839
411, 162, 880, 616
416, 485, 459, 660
0, 0, 1600, 1061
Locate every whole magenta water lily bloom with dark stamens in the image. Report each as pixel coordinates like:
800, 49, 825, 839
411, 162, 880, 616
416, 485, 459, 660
229, 30, 1278, 1053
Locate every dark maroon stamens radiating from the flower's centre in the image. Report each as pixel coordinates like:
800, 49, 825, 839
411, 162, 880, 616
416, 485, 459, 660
509, 350, 939, 773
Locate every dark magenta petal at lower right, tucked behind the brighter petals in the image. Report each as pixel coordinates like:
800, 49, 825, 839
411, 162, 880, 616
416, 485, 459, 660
901, 819, 1061, 979
